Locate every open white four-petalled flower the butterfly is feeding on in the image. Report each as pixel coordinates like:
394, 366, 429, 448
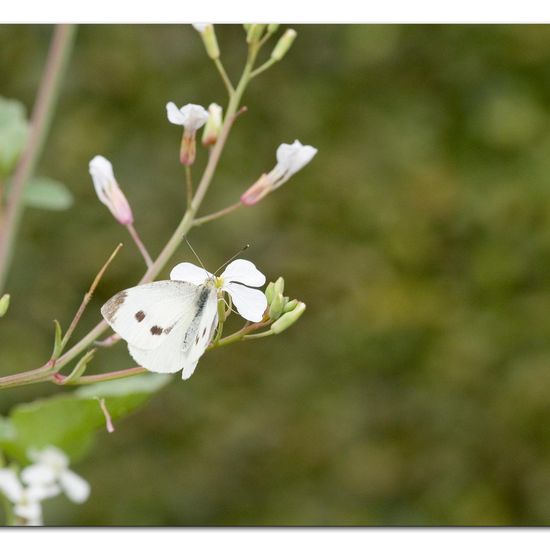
170, 260, 267, 322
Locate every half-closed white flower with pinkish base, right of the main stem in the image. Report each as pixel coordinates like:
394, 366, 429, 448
241, 140, 317, 206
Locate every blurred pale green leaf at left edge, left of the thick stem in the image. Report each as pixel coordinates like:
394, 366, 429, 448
0, 97, 29, 176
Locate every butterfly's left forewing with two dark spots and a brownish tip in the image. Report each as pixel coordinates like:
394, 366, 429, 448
101, 281, 204, 350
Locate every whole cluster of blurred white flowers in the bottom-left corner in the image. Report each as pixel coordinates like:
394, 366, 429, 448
0, 447, 90, 525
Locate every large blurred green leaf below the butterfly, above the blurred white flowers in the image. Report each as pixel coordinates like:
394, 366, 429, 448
0, 374, 171, 463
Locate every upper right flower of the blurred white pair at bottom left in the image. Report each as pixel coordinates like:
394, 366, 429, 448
21, 447, 90, 503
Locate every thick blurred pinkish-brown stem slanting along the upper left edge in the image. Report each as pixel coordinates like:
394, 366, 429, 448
0, 25, 76, 294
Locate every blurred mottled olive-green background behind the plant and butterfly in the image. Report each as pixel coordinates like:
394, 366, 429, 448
0, 25, 550, 525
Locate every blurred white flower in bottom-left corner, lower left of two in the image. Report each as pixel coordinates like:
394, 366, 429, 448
0, 468, 59, 525
